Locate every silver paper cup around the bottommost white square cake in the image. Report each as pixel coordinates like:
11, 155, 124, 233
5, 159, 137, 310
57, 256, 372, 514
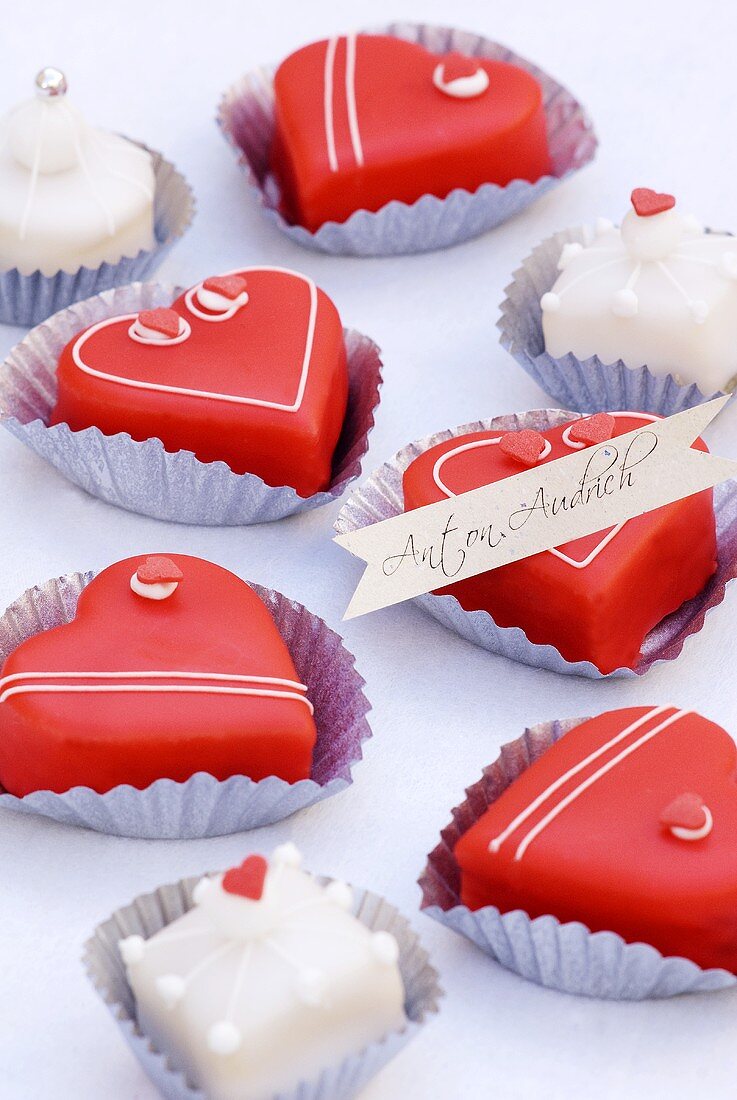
84, 876, 442, 1100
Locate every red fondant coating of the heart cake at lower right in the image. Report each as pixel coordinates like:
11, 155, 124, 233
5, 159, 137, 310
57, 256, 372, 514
455, 707, 737, 970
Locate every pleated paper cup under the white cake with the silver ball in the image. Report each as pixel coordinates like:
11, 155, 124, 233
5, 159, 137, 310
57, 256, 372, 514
0, 142, 195, 326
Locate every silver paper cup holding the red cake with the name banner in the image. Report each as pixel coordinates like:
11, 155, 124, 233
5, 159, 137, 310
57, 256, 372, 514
334, 409, 737, 680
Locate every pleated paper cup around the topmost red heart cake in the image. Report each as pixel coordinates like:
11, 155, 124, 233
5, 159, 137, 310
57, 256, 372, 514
217, 23, 597, 256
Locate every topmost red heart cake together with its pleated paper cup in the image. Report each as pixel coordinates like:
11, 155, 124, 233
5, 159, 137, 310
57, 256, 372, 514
218, 23, 596, 255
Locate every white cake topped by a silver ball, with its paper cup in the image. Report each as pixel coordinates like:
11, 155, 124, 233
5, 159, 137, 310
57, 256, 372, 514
0, 67, 194, 326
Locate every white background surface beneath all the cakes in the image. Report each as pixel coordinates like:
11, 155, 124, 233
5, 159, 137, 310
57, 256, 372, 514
0, 0, 737, 1100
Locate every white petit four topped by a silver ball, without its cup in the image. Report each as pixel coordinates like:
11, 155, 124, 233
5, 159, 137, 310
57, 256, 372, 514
0, 68, 154, 275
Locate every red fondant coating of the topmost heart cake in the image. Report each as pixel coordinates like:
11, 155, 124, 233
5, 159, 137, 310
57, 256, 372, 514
273, 34, 550, 230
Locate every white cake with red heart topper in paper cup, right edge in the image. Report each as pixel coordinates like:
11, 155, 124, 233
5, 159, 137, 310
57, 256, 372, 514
498, 187, 737, 416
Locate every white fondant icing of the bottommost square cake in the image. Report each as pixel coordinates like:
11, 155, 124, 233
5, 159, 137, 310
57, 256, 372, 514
121, 860, 406, 1100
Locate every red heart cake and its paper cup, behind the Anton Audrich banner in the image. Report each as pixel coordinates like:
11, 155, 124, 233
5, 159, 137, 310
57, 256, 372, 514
336, 409, 737, 678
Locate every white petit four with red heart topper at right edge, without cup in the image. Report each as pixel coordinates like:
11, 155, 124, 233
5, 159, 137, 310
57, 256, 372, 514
540, 187, 737, 394
